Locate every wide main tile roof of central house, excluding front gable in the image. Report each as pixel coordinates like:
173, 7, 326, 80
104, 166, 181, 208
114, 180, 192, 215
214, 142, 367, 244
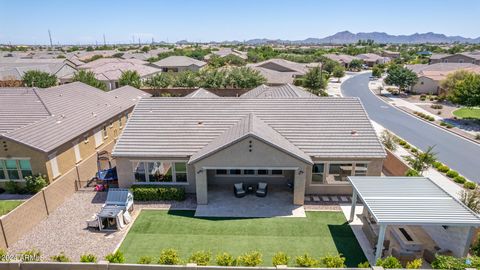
114, 97, 385, 158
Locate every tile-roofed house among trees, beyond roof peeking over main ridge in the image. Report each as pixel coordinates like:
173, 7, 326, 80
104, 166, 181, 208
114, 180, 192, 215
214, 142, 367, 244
247, 59, 320, 85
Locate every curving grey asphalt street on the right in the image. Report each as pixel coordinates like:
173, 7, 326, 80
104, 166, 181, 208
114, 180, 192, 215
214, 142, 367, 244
342, 73, 480, 182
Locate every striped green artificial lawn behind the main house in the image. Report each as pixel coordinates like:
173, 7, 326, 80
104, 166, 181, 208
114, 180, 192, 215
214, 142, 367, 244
120, 210, 366, 267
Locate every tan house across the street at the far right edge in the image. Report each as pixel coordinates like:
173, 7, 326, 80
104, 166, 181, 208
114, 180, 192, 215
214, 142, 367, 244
406, 63, 480, 94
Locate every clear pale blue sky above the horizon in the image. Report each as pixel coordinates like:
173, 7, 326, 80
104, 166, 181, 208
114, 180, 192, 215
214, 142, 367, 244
0, 0, 480, 44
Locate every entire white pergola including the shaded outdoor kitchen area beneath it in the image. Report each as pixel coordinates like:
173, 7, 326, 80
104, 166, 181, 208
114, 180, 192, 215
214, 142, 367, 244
349, 176, 480, 264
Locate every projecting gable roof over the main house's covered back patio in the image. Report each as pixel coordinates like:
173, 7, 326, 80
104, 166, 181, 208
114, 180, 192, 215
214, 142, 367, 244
188, 113, 313, 164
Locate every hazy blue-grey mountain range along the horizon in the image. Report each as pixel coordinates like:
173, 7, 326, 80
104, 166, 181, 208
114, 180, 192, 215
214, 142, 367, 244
194, 31, 480, 45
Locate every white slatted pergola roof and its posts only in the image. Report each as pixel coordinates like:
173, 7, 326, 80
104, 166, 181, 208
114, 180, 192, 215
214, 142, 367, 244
348, 176, 480, 261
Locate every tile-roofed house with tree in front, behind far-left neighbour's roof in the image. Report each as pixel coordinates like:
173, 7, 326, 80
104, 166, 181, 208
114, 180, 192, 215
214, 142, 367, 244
79, 58, 161, 90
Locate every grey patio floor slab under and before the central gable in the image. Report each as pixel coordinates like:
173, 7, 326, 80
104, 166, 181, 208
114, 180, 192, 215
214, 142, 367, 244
195, 187, 306, 217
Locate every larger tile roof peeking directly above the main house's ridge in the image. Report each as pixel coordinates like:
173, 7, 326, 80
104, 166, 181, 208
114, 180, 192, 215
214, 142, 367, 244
240, 84, 318, 98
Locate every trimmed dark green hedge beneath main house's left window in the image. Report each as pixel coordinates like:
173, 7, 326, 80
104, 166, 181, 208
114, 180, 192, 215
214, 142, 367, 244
132, 185, 185, 201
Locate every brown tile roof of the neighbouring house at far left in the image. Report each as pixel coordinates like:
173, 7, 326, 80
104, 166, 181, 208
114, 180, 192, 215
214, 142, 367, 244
0, 82, 149, 152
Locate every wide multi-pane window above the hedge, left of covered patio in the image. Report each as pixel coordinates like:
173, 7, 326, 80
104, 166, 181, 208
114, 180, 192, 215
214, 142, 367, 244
133, 161, 187, 183
